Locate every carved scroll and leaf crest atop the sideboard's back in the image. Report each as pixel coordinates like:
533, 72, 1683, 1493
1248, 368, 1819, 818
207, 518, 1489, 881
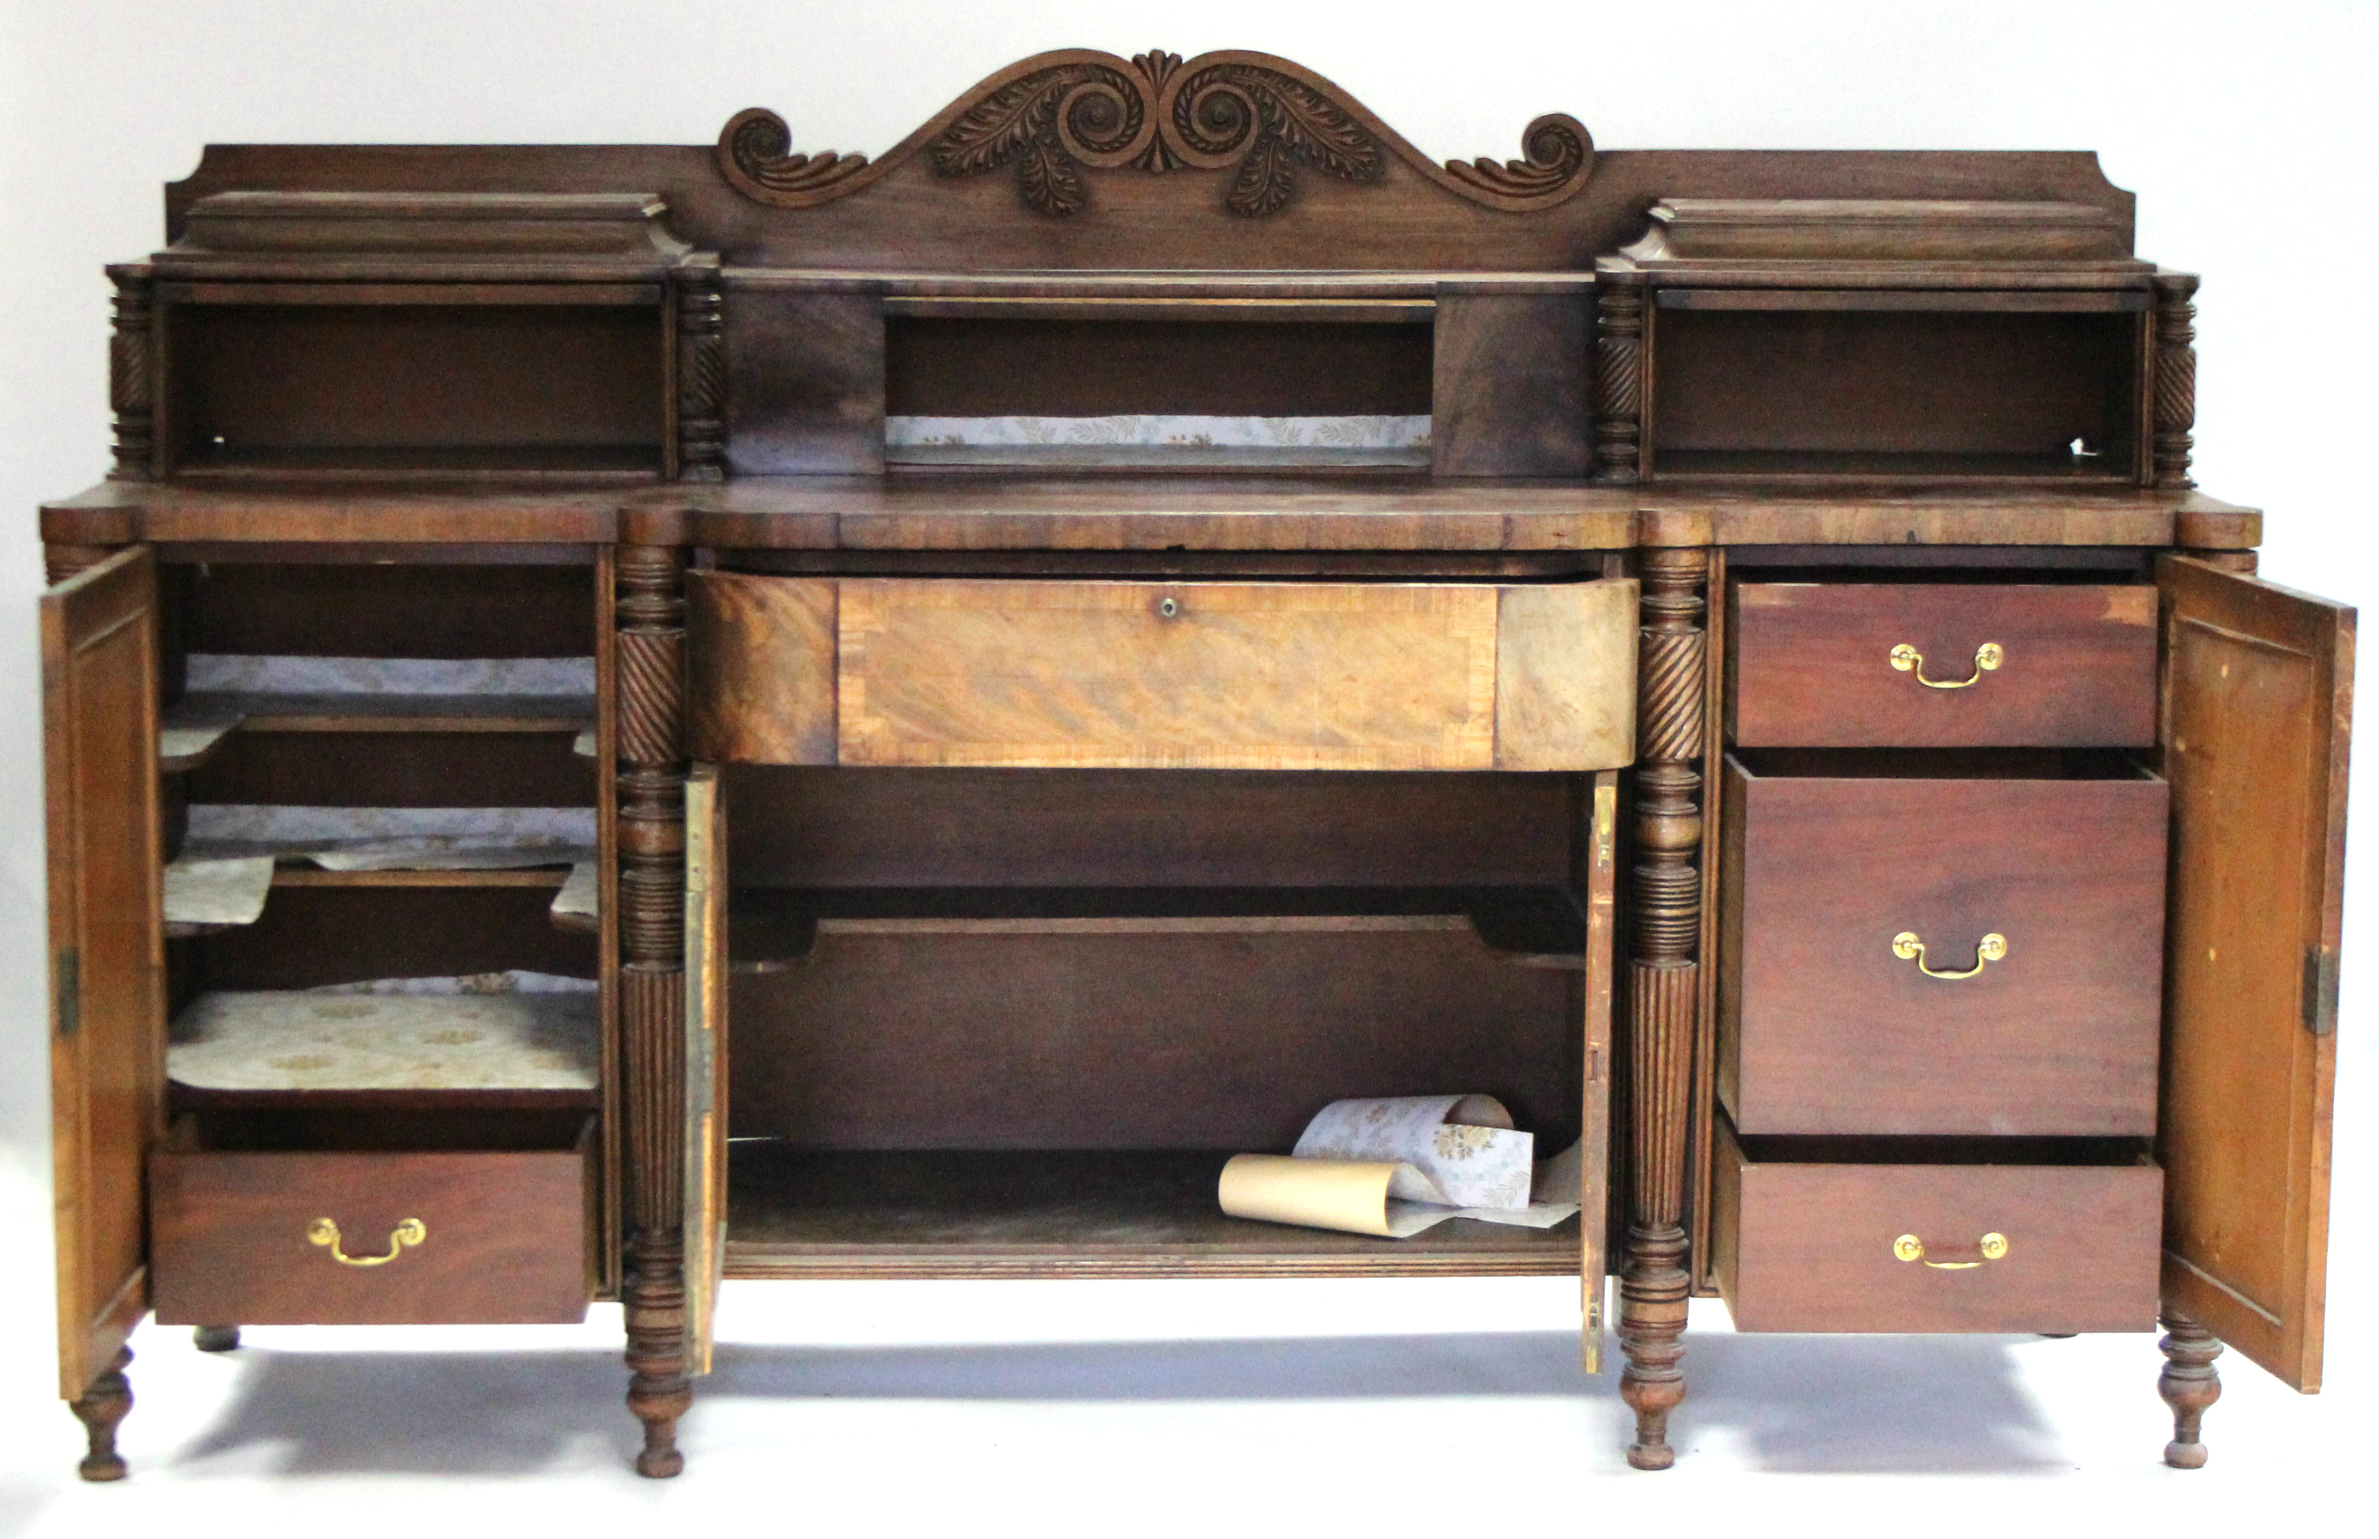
718, 50, 1594, 219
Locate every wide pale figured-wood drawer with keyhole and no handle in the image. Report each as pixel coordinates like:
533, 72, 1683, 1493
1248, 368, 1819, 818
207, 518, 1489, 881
688, 571, 1637, 771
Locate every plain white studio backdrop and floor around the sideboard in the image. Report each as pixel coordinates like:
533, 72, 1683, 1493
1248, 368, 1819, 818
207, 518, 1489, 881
0, 0, 2379, 1534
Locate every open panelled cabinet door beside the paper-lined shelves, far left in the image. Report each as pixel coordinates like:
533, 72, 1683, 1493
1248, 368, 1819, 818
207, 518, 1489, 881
40, 545, 164, 1399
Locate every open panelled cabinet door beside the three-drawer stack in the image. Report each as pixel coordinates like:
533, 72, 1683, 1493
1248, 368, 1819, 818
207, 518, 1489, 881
2158, 557, 2355, 1392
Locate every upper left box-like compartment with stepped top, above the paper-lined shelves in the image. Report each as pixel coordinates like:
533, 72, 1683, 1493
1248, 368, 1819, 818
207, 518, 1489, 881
114, 193, 718, 483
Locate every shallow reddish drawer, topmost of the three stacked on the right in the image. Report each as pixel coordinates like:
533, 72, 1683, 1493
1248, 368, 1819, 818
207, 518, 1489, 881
1727, 583, 2155, 747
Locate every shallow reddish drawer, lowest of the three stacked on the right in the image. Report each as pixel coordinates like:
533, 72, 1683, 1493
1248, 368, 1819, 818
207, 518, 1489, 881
1711, 1132, 2165, 1332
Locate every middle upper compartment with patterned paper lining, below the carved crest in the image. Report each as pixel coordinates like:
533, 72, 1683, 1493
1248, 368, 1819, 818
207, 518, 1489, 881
726, 269, 1592, 476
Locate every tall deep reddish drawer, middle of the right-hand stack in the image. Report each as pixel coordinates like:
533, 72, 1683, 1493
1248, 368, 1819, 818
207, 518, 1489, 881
1718, 754, 2170, 1137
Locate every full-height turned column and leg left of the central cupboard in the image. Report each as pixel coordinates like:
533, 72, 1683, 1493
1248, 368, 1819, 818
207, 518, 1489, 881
616, 545, 692, 1477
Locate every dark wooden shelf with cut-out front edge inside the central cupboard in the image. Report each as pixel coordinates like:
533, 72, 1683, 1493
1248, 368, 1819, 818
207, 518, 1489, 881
728, 887, 1587, 973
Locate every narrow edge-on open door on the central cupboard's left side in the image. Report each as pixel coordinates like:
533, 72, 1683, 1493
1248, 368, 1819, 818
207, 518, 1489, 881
685, 764, 728, 1372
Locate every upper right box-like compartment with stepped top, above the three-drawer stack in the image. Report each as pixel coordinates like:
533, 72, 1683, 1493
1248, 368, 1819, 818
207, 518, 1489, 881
1596, 197, 2196, 485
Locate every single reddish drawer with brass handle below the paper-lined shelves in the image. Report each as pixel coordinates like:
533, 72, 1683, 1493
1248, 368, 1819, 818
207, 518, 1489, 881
147, 1123, 595, 1325
